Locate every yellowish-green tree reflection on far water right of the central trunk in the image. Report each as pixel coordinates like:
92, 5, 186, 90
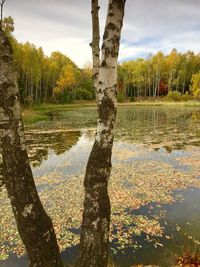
117, 106, 200, 150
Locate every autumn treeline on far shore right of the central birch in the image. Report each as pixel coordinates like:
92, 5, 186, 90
118, 49, 200, 98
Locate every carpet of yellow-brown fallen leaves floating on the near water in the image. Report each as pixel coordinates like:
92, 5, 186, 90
0, 144, 200, 259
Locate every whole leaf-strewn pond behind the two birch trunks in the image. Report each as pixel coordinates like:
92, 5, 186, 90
0, 106, 200, 267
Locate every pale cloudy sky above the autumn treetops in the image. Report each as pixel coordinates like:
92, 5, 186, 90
4, 0, 200, 67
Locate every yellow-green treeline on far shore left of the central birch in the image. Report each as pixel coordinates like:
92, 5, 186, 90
3, 17, 94, 104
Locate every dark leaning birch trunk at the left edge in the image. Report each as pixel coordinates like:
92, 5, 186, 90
0, 28, 63, 267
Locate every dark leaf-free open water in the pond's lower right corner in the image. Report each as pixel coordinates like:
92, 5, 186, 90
121, 189, 200, 267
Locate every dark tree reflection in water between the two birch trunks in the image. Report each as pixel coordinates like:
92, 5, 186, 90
26, 130, 80, 167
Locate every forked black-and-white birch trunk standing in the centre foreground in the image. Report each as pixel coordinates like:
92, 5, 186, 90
76, 0, 125, 267
